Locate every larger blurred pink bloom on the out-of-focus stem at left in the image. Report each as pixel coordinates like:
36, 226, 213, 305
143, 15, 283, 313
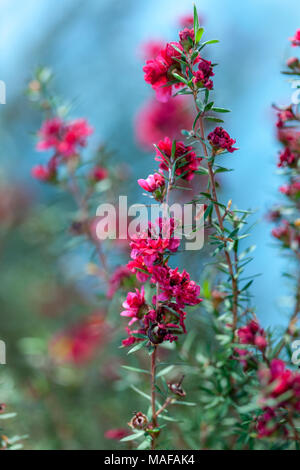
36, 117, 93, 157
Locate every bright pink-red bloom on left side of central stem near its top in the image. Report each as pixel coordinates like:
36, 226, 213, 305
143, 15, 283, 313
143, 42, 182, 103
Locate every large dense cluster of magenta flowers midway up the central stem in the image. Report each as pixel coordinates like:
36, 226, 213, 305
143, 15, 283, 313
121, 215, 200, 346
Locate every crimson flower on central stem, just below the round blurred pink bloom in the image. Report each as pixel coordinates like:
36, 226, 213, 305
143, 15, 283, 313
155, 137, 201, 181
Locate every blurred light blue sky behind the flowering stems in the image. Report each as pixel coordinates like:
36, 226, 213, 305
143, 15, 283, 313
0, 0, 300, 324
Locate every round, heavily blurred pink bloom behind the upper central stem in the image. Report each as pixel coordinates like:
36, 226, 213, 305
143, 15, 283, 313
135, 96, 193, 150
